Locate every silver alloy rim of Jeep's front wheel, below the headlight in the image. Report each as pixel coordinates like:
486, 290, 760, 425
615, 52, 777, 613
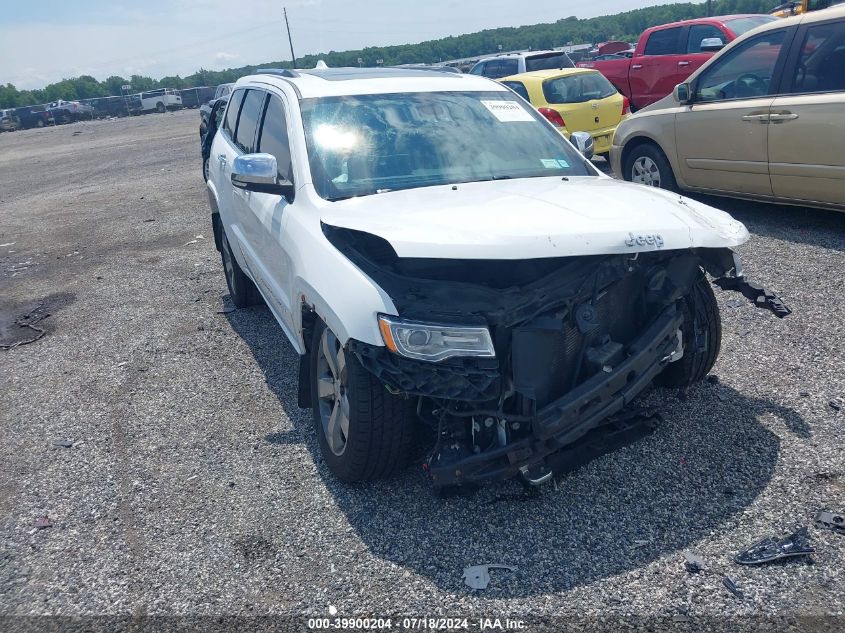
315, 328, 349, 456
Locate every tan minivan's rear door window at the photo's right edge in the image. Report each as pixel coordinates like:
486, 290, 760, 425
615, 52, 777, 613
791, 20, 845, 93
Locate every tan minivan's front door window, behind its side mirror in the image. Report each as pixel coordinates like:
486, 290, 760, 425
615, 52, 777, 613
695, 29, 785, 102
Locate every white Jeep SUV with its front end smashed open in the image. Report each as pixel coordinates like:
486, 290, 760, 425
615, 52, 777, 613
208, 69, 788, 486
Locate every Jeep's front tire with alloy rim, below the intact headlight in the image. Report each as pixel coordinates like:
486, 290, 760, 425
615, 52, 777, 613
310, 321, 414, 482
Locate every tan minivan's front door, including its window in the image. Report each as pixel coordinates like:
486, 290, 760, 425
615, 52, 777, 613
675, 28, 793, 196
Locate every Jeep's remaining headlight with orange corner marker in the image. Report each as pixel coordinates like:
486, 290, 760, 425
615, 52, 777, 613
378, 314, 496, 361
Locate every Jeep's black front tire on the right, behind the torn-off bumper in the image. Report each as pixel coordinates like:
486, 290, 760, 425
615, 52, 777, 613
654, 273, 722, 388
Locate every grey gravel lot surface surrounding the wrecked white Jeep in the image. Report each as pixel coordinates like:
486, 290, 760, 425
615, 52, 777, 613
0, 111, 845, 628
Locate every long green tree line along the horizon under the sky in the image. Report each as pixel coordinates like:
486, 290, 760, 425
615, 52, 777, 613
0, 0, 777, 108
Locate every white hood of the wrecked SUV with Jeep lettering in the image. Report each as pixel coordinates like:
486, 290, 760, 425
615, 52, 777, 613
322, 177, 748, 259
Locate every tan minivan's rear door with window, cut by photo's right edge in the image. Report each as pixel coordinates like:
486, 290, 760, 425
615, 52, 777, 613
768, 19, 845, 206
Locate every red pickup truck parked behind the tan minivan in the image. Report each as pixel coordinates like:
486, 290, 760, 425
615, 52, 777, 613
577, 15, 777, 110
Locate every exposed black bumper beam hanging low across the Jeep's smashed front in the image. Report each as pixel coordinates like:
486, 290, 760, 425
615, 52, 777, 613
428, 306, 683, 486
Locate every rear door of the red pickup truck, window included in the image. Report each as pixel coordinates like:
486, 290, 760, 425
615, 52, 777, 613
629, 26, 687, 109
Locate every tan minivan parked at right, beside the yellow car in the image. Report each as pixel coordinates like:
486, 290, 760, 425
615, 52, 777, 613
611, 5, 845, 210
